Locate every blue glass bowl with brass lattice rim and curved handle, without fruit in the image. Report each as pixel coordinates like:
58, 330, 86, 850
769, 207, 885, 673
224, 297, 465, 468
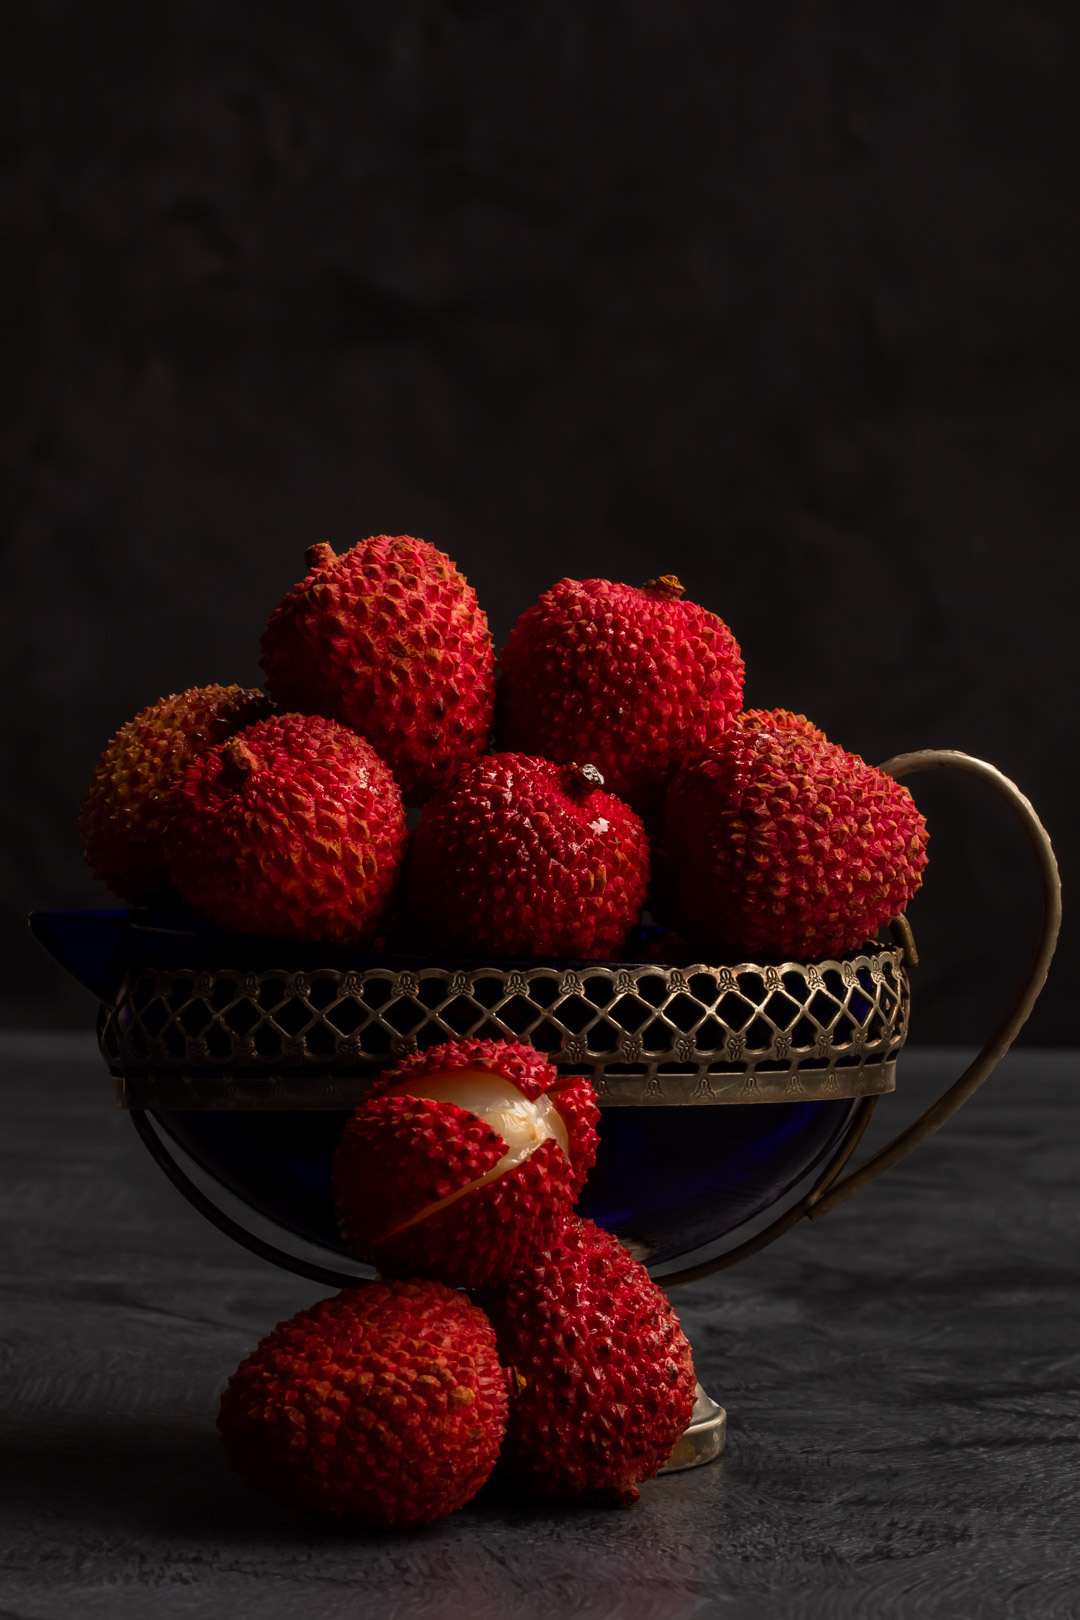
32, 750, 1059, 1285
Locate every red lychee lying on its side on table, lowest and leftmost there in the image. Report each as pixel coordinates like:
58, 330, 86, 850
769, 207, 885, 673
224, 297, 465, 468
217, 1281, 507, 1529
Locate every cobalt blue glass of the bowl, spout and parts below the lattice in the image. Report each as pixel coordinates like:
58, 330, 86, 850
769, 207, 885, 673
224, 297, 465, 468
31, 912, 880, 1265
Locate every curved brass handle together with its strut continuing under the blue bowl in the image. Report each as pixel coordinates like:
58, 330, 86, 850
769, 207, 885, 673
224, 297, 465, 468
657, 748, 1061, 1288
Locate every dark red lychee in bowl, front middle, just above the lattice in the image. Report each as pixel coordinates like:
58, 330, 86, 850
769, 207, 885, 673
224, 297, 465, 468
405, 753, 649, 957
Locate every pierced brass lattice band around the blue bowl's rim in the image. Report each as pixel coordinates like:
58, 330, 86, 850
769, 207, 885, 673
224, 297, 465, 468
100, 946, 908, 1108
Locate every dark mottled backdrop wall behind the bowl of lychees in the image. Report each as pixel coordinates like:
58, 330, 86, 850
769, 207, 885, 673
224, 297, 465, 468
0, 0, 1080, 1042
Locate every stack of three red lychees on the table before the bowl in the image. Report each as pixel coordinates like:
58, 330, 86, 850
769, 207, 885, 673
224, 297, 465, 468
219, 1040, 696, 1526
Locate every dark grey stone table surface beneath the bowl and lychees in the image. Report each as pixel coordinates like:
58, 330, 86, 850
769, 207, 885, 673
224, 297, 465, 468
0, 1035, 1080, 1620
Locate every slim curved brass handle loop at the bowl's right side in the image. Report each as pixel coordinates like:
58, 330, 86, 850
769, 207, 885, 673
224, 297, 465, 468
806, 748, 1061, 1220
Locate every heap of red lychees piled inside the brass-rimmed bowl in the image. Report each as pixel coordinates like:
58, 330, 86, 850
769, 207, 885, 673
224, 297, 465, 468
81, 535, 926, 961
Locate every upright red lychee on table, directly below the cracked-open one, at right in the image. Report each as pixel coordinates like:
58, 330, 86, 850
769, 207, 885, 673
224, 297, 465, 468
481, 1217, 695, 1507
